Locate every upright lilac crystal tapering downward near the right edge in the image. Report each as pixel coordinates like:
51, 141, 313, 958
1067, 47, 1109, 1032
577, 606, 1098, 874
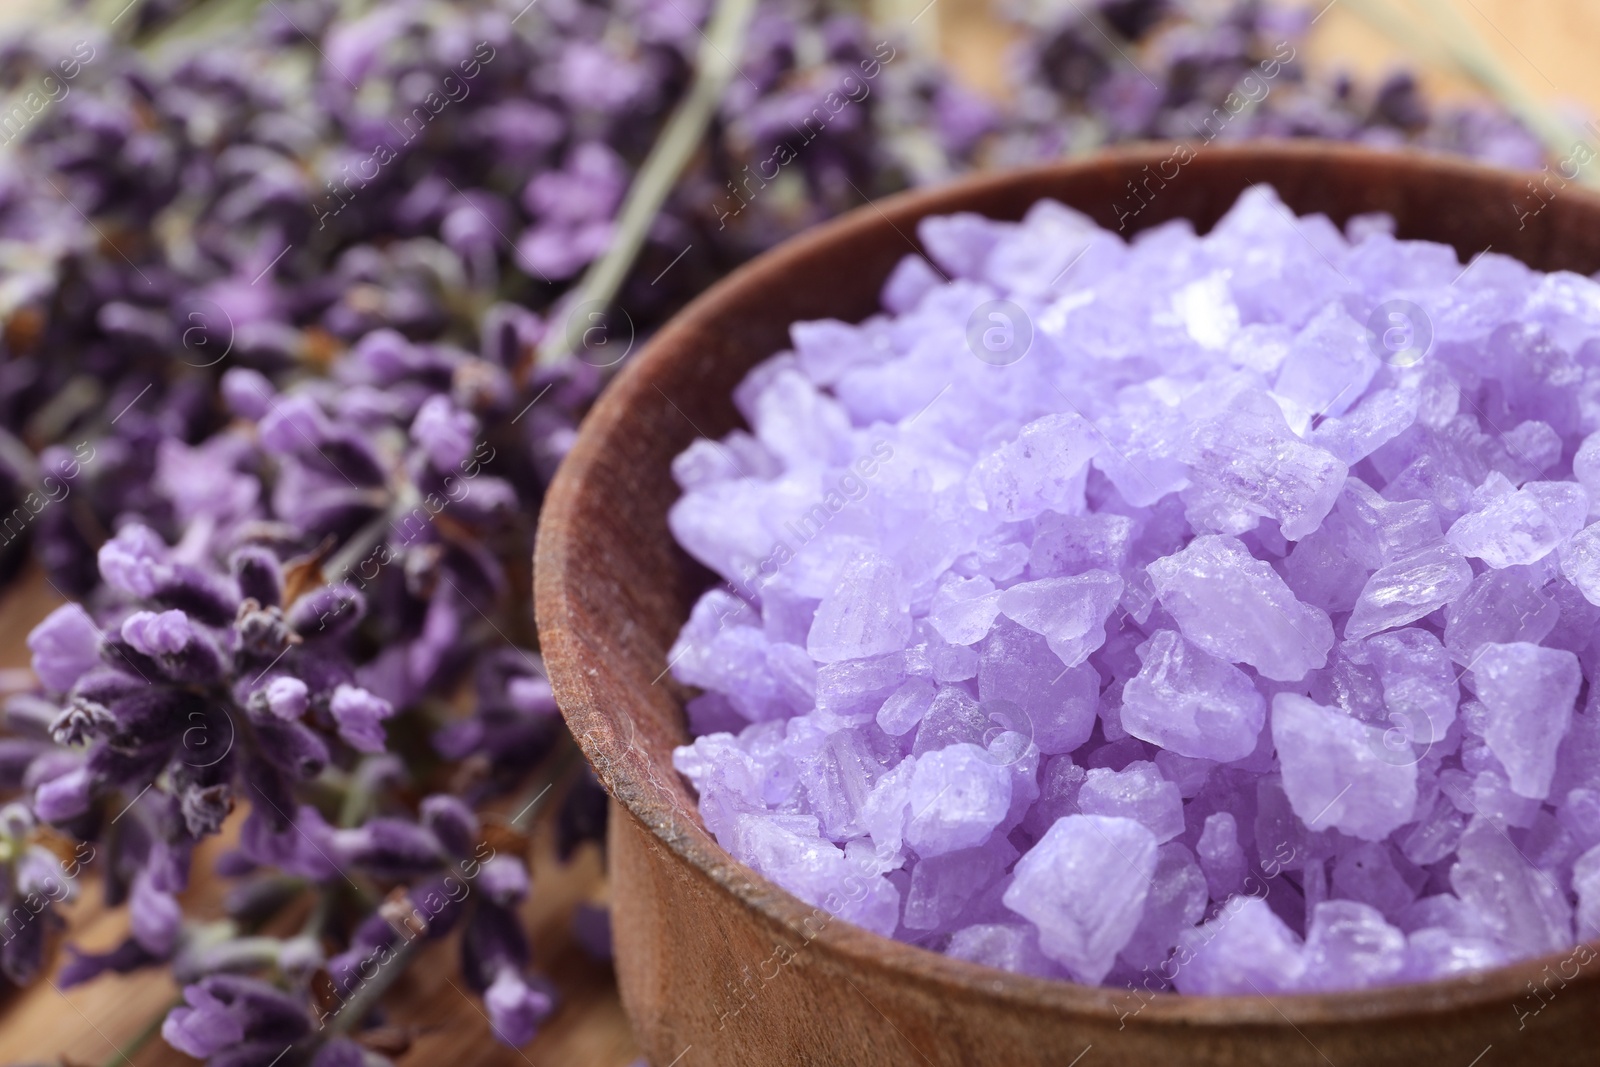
1472, 641, 1584, 800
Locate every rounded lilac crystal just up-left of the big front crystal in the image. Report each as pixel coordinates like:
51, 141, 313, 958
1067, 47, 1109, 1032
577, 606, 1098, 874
906, 744, 1011, 857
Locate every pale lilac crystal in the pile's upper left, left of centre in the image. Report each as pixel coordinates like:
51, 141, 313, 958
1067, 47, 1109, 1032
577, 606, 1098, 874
968, 414, 1101, 523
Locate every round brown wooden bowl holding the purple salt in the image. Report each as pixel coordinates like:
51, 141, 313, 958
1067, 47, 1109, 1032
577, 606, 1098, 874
536, 142, 1600, 1067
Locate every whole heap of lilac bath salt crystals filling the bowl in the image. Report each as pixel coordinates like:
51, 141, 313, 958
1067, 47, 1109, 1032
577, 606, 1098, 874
670, 187, 1600, 993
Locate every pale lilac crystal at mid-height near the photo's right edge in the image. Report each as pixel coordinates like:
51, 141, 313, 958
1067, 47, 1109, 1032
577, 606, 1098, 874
1446, 472, 1589, 569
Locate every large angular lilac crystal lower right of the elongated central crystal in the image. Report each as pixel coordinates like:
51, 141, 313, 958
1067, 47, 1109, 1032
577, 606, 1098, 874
1272, 693, 1416, 841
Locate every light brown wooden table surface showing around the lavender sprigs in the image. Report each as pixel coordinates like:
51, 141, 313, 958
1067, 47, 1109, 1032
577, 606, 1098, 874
0, 0, 1600, 1067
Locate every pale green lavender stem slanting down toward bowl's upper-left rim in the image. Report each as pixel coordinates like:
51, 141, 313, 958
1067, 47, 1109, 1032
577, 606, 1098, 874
539, 0, 755, 366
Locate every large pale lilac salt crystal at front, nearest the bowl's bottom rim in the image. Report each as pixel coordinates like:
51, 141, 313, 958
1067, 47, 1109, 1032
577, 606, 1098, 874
1003, 814, 1158, 985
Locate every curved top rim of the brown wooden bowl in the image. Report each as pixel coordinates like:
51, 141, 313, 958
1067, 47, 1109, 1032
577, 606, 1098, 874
534, 139, 1600, 1029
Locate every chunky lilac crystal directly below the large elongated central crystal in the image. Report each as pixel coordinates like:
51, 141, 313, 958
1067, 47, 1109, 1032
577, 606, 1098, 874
1122, 630, 1267, 763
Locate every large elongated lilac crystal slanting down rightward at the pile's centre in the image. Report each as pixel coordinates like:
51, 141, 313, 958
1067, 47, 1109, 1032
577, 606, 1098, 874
1149, 536, 1333, 681
